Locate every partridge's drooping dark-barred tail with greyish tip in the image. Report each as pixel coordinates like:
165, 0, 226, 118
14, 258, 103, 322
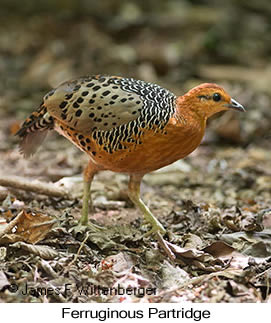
15, 103, 54, 157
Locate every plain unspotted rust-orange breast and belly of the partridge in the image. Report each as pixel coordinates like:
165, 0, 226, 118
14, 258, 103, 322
90, 119, 204, 174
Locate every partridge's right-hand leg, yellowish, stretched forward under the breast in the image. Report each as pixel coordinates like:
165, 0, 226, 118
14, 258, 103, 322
128, 175, 166, 235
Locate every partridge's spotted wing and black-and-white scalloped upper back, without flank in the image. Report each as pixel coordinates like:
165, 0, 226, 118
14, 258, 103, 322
44, 76, 175, 134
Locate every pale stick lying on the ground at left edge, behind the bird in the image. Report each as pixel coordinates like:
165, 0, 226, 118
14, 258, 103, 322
0, 176, 68, 197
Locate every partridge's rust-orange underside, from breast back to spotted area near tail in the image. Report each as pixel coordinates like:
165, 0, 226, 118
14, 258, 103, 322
55, 116, 204, 174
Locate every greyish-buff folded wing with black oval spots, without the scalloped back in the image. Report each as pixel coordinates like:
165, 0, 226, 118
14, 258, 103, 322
44, 77, 146, 133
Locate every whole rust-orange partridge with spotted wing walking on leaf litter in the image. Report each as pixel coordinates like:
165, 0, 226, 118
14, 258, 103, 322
15, 75, 244, 232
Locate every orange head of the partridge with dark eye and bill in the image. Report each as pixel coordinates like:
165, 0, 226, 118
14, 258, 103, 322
179, 83, 245, 119
